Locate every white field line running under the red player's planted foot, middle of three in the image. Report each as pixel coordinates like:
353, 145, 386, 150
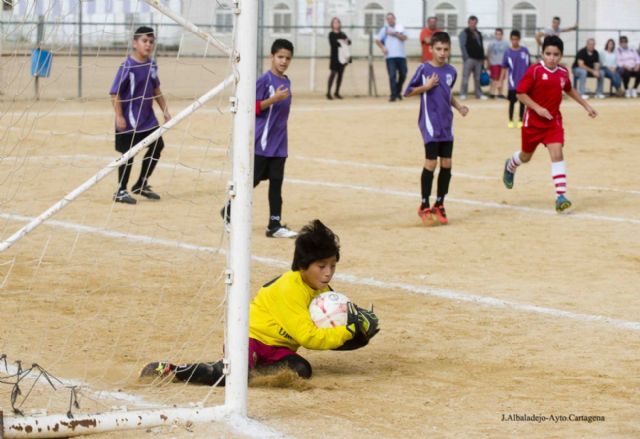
0, 154, 640, 224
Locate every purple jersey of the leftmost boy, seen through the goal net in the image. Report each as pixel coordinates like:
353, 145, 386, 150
109, 56, 160, 132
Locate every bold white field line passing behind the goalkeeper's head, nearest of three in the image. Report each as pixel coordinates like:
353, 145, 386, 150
0, 213, 640, 331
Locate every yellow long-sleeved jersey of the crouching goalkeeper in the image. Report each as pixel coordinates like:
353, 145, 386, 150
249, 271, 353, 351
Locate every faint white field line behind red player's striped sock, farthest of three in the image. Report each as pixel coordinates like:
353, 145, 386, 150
5, 127, 640, 195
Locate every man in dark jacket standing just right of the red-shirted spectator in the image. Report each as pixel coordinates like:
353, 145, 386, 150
458, 15, 488, 100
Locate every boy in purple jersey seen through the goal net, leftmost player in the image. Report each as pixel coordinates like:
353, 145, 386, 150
109, 26, 171, 204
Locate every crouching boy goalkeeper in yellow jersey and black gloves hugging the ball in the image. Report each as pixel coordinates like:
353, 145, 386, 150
140, 220, 379, 386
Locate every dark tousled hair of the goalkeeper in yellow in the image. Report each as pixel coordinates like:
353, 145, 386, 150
291, 220, 340, 271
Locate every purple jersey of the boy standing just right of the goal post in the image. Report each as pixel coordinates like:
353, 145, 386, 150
255, 71, 291, 157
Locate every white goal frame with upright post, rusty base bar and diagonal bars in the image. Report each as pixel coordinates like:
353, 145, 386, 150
0, 0, 258, 438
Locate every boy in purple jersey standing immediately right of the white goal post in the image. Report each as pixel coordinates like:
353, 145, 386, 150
220, 39, 298, 238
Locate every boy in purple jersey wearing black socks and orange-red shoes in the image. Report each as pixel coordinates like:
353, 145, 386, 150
404, 32, 469, 226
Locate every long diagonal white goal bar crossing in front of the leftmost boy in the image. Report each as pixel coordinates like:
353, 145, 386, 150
0, 75, 235, 253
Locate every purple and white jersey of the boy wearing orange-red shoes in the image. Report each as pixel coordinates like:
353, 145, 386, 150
404, 62, 458, 144
